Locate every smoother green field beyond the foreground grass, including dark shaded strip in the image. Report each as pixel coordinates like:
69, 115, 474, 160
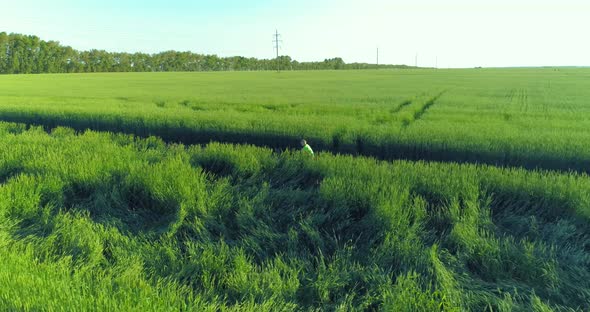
0, 68, 590, 172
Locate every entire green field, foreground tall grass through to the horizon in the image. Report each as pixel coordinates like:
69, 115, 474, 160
0, 68, 590, 311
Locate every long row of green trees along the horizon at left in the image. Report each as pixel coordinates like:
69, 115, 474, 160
0, 32, 408, 74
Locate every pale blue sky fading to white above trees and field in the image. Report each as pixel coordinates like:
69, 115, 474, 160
0, 0, 590, 67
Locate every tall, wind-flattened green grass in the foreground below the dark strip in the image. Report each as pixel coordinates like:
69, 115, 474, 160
0, 123, 590, 311
